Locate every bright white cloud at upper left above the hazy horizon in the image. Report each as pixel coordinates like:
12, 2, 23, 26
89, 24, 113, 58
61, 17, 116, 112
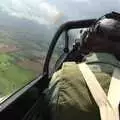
0, 0, 61, 24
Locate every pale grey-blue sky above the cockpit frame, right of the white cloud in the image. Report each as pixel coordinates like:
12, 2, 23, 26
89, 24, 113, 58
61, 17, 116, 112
52, 0, 120, 20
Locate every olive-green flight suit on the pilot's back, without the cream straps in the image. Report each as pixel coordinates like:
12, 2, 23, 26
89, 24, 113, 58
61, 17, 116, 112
47, 53, 120, 120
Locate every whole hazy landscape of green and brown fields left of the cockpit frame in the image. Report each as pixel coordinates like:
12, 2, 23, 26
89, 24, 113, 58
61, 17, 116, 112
0, 12, 52, 100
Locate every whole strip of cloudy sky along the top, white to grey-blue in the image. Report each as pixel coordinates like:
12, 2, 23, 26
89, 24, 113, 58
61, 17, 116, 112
0, 0, 120, 24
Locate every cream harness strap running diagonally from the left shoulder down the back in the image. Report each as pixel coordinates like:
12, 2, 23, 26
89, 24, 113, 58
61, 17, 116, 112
79, 63, 117, 120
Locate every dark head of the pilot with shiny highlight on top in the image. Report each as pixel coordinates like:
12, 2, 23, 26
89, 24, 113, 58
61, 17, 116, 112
83, 12, 120, 58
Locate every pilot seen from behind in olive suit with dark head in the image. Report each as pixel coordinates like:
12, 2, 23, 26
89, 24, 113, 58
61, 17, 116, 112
48, 12, 120, 120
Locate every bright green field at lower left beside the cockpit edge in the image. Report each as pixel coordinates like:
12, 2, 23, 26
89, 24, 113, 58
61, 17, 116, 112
0, 54, 36, 97
